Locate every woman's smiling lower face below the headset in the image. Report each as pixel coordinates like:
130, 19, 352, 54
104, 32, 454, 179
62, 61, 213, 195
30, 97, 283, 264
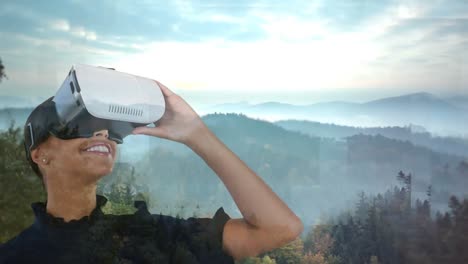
34, 130, 117, 183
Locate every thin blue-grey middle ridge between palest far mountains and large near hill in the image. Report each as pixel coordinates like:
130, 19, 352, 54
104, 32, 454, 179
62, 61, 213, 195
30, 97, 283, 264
275, 120, 468, 157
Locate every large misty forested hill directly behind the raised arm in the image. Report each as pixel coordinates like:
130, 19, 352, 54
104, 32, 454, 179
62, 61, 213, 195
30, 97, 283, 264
126, 114, 468, 222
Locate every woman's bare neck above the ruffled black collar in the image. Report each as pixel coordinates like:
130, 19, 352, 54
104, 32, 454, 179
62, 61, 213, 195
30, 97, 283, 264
47, 182, 96, 222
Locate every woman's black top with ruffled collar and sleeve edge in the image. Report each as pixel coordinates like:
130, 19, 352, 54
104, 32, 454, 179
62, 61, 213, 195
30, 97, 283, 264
0, 195, 234, 264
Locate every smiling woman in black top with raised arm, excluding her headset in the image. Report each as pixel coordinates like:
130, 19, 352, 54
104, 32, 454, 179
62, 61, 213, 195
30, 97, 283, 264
0, 83, 303, 263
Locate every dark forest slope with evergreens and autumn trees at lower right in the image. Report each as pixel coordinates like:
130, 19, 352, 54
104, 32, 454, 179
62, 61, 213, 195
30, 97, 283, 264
241, 172, 468, 264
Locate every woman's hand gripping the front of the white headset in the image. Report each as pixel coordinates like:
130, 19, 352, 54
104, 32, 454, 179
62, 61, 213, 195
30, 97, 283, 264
133, 81, 206, 144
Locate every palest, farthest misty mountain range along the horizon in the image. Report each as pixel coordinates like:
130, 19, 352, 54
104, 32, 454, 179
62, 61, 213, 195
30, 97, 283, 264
205, 93, 468, 136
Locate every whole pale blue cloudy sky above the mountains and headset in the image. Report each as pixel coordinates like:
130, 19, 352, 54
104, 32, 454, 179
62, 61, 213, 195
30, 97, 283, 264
0, 0, 468, 104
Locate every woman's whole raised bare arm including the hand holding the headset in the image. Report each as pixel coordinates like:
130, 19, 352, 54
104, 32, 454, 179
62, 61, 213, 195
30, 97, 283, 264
134, 83, 303, 259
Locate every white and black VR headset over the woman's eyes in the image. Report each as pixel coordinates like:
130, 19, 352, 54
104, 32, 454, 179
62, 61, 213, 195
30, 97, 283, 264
49, 64, 165, 143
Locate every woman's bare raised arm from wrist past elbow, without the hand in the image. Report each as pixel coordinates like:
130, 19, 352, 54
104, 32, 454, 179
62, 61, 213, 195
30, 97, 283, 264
187, 123, 302, 259
